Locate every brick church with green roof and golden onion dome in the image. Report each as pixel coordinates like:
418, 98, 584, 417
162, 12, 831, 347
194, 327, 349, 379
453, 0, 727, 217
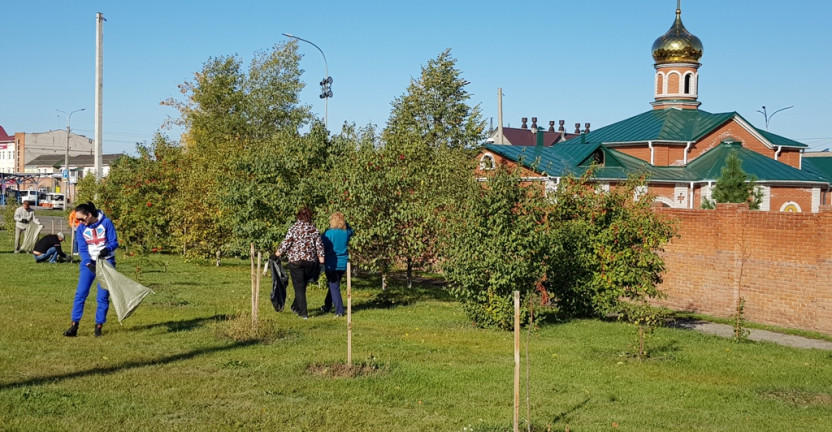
477, 4, 832, 212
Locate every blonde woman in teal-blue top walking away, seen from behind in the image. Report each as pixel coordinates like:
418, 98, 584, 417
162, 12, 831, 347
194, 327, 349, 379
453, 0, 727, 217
321, 212, 353, 316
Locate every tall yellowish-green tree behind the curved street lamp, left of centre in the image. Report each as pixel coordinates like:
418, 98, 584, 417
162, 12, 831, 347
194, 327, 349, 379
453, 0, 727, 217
163, 41, 311, 256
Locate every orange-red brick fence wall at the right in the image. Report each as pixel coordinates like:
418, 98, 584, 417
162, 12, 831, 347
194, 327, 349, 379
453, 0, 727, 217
655, 204, 832, 334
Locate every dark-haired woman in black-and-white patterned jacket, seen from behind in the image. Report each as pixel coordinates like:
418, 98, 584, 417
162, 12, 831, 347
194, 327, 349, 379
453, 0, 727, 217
275, 207, 324, 319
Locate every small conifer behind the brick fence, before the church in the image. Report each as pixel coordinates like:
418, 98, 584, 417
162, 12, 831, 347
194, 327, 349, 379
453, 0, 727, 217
702, 150, 763, 210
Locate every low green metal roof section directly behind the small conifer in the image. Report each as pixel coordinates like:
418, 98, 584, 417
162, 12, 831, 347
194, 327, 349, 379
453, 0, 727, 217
687, 142, 828, 183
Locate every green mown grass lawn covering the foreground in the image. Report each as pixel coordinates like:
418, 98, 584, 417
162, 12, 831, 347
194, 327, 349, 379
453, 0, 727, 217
0, 231, 832, 432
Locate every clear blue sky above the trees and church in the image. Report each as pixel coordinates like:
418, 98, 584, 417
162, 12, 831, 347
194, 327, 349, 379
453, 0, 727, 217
0, 0, 832, 153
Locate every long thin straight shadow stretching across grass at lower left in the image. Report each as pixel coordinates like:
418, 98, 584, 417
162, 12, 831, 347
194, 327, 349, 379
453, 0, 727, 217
0, 340, 259, 391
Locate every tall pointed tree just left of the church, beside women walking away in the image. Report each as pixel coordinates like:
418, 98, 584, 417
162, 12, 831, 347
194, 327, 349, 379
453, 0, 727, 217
368, 50, 485, 285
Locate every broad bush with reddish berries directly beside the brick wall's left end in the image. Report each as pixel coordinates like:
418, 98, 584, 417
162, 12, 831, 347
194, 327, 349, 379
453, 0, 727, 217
547, 172, 675, 316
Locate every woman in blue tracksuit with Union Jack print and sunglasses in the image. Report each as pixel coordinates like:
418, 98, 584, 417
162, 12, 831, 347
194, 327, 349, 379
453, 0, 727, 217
64, 202, 118, 337
